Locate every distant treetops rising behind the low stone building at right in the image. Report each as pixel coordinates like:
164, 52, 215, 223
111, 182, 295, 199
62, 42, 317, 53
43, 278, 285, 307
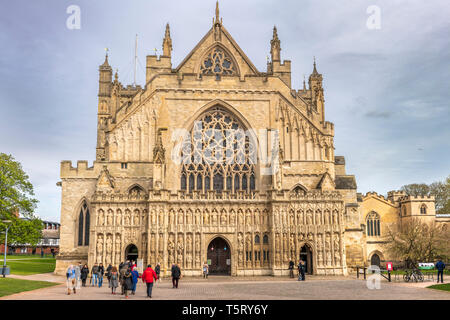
400, 176, 450, 213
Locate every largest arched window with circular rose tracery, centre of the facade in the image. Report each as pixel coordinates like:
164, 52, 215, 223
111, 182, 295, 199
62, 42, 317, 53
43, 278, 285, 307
180, 106, 257, 192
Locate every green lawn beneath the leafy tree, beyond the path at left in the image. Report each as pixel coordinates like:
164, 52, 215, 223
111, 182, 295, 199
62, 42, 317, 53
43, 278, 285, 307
0, 256, 56, 275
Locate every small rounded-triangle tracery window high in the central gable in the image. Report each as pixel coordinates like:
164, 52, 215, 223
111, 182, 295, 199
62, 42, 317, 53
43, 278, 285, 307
200, 47, 237, 80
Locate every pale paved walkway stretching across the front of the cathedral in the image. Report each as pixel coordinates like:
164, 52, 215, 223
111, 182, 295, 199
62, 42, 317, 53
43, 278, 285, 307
0, 274, 450, 300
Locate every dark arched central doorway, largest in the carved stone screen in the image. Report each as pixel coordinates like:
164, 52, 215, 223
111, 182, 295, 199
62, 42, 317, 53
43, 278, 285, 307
207, 237, 231, 275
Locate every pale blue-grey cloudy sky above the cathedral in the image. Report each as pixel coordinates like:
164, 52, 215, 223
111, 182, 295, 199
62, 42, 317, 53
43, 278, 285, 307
0, 0, 450, 221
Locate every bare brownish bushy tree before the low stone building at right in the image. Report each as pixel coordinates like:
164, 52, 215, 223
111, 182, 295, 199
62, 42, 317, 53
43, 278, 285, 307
385, 219, 450, 267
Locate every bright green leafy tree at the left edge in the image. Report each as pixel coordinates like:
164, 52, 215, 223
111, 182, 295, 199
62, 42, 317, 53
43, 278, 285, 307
0, 153, 43, 245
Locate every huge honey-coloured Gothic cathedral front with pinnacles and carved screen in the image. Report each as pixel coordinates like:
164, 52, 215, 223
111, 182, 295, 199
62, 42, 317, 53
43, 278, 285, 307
56, 2, 444, 275
